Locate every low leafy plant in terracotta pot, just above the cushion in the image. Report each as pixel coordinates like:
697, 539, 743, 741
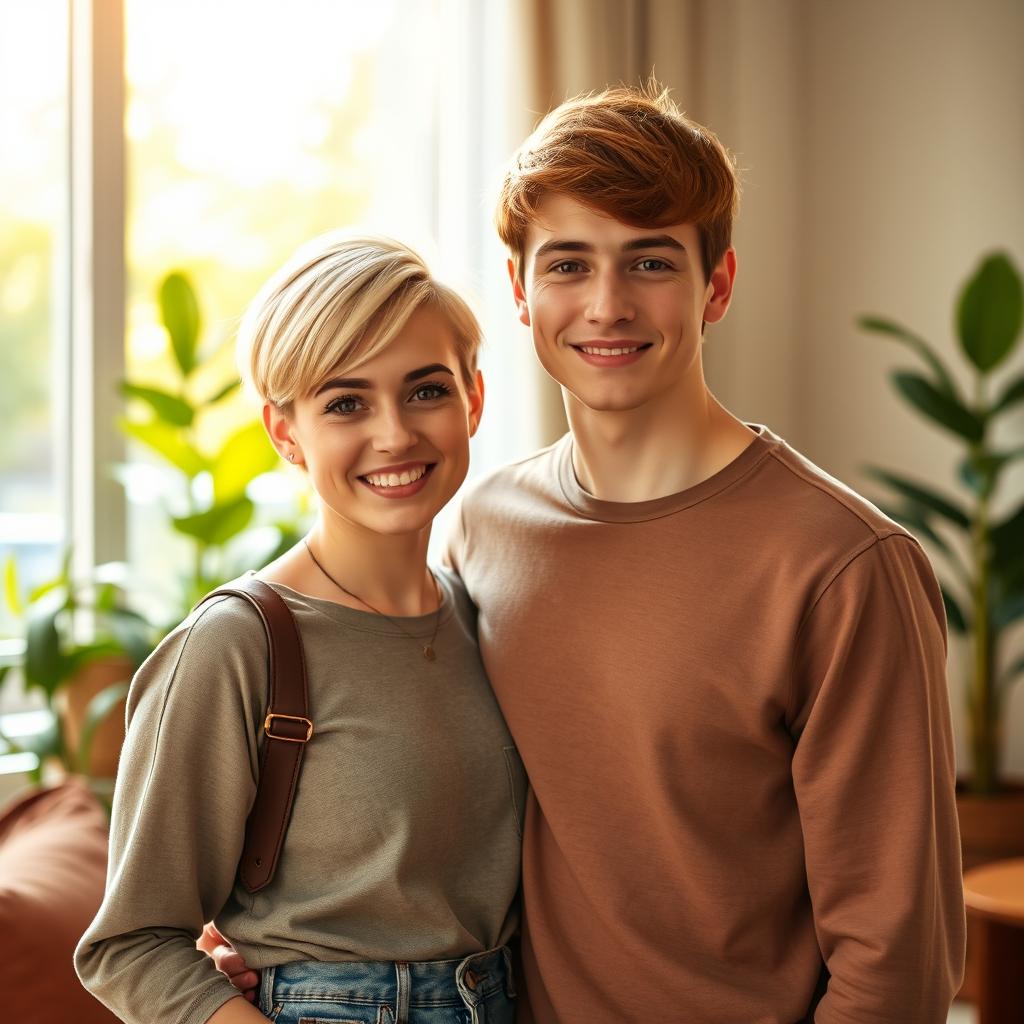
0, 552, 158, 791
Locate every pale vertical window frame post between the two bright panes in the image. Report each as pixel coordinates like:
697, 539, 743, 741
0, 0, 125, 684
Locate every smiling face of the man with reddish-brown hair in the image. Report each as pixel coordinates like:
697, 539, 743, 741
513, 195, 735, 412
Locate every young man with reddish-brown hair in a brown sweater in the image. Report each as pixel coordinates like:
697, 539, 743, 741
209, 83, 965, 1024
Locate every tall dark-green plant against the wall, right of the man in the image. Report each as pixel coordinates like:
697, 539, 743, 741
858, 253, 1024, 853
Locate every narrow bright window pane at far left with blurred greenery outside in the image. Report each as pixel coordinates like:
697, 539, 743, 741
0, 0, 68, 675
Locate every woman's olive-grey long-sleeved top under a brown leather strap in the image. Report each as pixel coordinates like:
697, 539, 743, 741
76, 574, 525, 1024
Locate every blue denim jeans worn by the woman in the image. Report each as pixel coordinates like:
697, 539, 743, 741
259, 947, 515, 1024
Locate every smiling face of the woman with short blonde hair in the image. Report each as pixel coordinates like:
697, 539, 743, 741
264, 306, 483, 535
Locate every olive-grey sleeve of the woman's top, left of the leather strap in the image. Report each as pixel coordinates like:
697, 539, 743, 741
75, 598, 266, 1024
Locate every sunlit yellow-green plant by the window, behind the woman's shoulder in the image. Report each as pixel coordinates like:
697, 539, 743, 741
120, 271, 298, 626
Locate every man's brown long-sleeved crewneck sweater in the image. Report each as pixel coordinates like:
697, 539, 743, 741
451, 427, 965, 1024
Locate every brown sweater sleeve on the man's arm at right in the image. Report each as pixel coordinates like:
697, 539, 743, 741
793, 535, 965, 1024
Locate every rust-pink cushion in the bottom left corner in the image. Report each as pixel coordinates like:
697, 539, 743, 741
0, 780, 117, 1024
